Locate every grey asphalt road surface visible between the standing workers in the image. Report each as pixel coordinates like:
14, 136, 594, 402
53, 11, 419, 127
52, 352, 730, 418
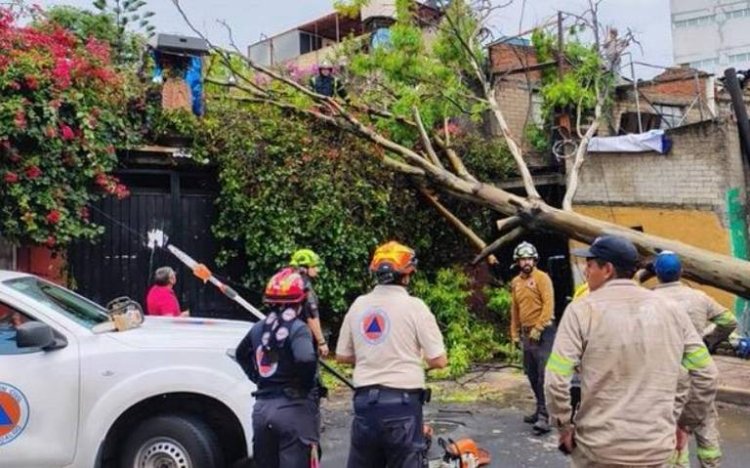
322, 401, 750, 468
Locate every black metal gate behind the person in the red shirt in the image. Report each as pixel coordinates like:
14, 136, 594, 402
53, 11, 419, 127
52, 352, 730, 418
69, 170, 247, 318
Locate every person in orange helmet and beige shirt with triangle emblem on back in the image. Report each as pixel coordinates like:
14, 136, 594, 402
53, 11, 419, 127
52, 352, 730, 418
336, 242, 448, 468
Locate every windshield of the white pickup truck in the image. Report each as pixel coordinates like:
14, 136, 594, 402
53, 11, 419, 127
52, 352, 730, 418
4, 277, 110, 328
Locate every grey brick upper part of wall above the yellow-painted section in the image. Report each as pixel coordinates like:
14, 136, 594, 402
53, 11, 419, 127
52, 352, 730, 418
575, 119, 745, 218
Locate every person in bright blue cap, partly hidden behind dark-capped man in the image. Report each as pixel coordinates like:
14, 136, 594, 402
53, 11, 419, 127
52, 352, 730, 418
653, 251, 737, 468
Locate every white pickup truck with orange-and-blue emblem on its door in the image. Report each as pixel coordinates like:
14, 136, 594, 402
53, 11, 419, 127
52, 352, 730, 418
0, 271, 255, 468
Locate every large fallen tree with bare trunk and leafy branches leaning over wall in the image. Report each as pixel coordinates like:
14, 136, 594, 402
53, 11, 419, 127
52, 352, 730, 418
173, 0, 750, 297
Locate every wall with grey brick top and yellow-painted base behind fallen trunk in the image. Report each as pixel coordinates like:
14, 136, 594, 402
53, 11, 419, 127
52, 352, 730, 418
575, 119, 747, 312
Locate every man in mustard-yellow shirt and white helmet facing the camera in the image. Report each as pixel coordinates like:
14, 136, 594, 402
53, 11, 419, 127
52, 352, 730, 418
510, 242, 555, 434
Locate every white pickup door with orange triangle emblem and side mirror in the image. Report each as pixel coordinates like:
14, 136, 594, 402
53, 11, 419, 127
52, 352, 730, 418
0, 293, 80, 468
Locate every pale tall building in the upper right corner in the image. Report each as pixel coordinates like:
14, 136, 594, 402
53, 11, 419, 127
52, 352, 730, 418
670, 0, 750, 75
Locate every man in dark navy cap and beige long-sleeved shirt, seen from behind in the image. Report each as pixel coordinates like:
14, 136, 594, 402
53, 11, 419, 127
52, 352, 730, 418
545, 236, 717, 467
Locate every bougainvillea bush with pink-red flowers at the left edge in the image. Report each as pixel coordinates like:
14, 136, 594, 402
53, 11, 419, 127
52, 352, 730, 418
0, 9, 128, 247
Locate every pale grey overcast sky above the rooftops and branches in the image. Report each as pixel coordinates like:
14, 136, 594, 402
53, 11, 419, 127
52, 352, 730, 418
41, 0, 672, 77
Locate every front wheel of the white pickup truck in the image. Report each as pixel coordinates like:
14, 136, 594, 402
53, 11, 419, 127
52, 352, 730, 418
120, 415, 224, 468
